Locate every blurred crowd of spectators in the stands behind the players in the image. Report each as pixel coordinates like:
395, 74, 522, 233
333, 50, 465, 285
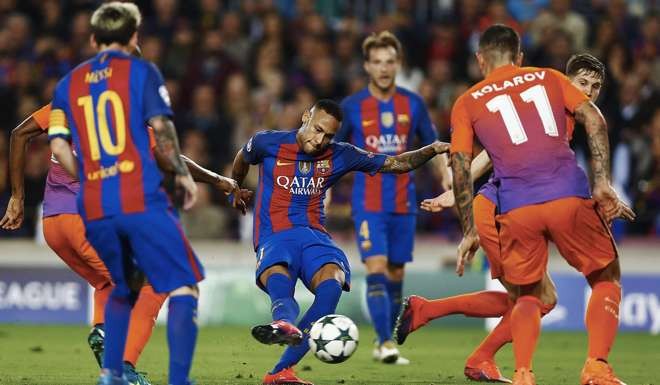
0, 0, 660, 238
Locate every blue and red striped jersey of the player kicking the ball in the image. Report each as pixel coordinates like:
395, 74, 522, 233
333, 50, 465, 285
242, 131, 386, 249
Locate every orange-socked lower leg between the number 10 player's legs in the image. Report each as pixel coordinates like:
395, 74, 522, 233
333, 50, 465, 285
124, 284, 167, 385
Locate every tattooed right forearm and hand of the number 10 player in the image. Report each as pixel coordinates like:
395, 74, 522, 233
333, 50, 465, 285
149, 115, 197, 210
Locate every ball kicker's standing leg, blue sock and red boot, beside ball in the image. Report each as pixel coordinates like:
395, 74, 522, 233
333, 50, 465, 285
263, 265, 342, 385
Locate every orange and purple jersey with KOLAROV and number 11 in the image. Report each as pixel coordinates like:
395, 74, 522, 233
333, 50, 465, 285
451, 65, 590, 213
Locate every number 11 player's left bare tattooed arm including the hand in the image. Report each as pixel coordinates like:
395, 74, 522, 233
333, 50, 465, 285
451, 152, 479, 276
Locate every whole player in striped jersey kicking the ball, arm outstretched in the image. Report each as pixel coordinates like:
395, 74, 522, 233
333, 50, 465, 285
232, 100, 447, 384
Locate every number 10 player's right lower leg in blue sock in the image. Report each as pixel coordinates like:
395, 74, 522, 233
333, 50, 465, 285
167, 286, 199, 385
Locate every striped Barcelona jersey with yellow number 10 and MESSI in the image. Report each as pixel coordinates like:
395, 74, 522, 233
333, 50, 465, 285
48, 50, 172, 220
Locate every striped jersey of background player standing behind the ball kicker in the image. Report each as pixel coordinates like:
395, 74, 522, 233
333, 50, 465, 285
335, 87, 437, 214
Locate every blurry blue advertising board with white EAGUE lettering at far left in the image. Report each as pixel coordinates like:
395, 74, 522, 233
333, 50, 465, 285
0, 267, 91, 324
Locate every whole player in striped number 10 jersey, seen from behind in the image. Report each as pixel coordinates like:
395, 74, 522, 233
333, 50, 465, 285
48, 1, 204, 385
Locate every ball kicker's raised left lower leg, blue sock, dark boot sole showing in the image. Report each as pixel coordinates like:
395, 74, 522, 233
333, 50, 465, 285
252, 265, 303, 345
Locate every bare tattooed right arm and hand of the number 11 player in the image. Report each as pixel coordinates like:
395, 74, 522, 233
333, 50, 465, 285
575, 101, 635, 222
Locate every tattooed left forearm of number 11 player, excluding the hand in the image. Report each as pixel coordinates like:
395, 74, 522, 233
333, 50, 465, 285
451, 152, 474, 234
